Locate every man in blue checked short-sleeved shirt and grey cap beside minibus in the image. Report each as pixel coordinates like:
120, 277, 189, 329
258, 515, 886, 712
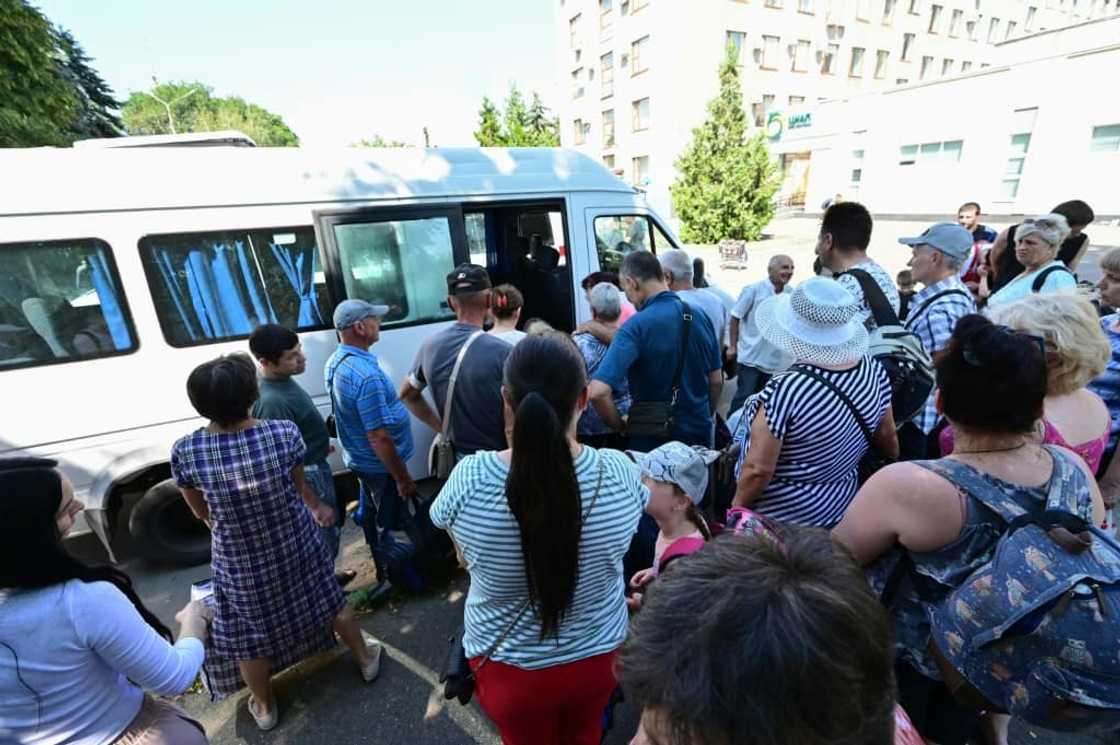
324, 300, 417, 596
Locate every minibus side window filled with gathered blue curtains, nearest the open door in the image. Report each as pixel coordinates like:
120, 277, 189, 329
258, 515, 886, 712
140, 226, 330, 346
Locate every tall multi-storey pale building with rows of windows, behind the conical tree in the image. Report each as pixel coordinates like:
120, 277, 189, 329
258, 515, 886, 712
553, 0, 1106, 216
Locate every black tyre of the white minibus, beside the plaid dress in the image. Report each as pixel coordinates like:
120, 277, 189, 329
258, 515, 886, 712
129, 478, 211, 565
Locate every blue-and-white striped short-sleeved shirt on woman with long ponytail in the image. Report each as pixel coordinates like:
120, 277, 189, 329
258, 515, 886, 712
431, 446, 650, 670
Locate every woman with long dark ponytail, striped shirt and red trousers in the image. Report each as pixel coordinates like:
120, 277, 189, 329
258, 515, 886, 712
431, 333, 650, 745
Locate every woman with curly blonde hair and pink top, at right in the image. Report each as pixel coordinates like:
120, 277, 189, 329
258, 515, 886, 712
941, 292, 1112, 473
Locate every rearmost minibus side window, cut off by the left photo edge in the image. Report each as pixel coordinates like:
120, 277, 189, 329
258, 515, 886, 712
0, 239, 137, 370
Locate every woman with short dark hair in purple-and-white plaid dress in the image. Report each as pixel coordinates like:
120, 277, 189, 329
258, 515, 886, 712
171, 354, 381, 729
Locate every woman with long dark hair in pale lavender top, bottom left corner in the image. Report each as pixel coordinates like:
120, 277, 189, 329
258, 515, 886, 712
0, 458, 209, 745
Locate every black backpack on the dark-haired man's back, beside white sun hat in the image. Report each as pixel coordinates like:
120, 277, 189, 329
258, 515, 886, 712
843, 269, 934, 426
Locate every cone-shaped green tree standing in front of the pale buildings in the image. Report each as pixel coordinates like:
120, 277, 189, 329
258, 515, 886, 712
670, 45, 780, 243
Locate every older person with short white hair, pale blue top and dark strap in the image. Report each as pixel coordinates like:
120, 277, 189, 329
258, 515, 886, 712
988, 213, 1077, 308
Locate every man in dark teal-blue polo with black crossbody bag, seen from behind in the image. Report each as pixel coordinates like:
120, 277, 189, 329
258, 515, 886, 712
590, 251, 724, 453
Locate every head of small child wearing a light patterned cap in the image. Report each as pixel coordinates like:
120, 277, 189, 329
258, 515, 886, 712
634, 441, 718, 522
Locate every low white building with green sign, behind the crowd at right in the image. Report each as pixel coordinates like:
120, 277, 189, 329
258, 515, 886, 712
772, 26, 1120, 215
